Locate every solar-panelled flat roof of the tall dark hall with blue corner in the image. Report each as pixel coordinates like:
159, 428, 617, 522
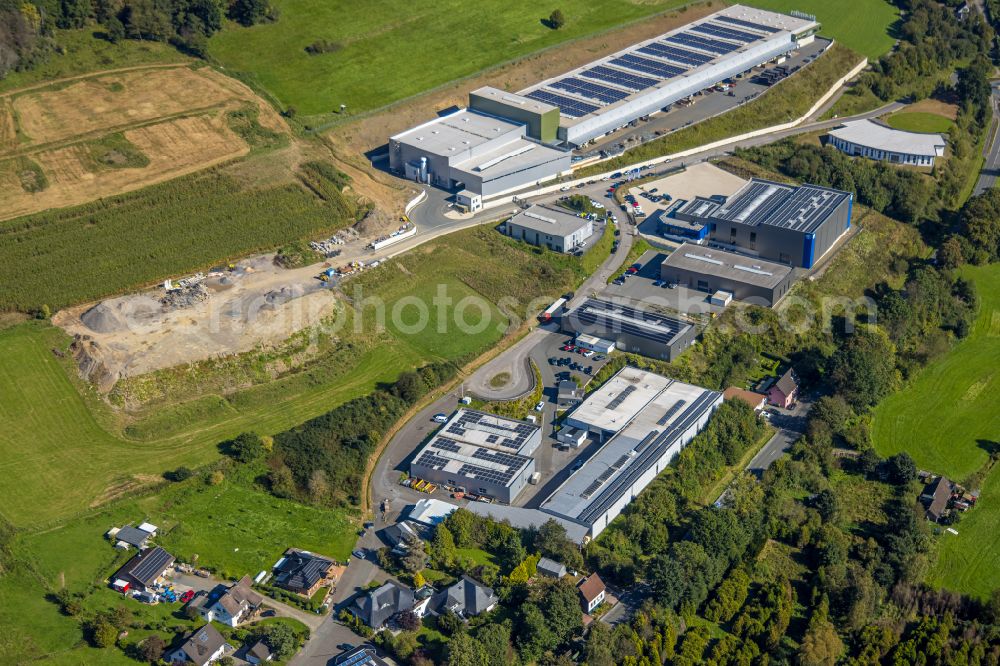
709, 178, 852, 233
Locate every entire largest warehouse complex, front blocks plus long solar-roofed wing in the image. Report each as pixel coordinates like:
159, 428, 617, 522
389, 5, 819, 200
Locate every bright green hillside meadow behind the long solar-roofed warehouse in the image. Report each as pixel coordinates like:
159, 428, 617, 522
209, 0, 898, 119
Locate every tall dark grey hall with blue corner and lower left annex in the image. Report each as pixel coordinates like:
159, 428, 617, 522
661, 178, 854, 268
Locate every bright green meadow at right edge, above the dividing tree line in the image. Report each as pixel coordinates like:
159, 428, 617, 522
872, 264, 1000, 481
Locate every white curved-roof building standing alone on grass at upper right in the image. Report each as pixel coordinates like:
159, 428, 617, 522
829, 120, 947, 166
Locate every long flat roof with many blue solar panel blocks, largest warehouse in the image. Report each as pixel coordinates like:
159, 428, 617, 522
518, 5, 818, 126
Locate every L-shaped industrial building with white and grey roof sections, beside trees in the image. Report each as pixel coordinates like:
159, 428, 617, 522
540, 366, 722, 539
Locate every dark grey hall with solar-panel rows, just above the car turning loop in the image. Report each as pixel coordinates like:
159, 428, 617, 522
560, 298, 698, 361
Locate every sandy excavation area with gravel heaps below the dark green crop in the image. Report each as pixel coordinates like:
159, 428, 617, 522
52, 255, 336, 392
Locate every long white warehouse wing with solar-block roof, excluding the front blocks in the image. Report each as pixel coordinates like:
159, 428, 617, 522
518, 5, 819, 146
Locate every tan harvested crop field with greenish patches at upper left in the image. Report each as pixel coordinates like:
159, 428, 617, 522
0, 66, 287, 220
